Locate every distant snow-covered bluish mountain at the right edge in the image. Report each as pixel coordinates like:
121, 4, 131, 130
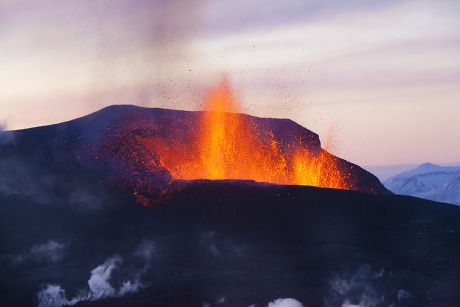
383, 163, 460, 205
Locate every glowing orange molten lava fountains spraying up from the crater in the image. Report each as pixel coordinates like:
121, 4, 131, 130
151, 81, 351, 189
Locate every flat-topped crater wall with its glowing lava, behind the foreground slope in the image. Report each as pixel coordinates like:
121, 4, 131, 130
2, 105, 391, 205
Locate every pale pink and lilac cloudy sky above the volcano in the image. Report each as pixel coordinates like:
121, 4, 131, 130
0, 0, 460, 165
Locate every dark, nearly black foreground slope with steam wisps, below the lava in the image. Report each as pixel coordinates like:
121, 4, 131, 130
0, 181, 460, 306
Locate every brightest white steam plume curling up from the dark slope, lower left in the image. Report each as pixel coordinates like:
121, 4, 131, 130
37, 241, 156, 307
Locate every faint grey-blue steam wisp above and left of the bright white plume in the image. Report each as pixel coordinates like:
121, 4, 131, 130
11, 240, 67, 264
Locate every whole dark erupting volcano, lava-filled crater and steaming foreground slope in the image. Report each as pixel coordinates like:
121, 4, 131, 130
0, 105, 460, 307
